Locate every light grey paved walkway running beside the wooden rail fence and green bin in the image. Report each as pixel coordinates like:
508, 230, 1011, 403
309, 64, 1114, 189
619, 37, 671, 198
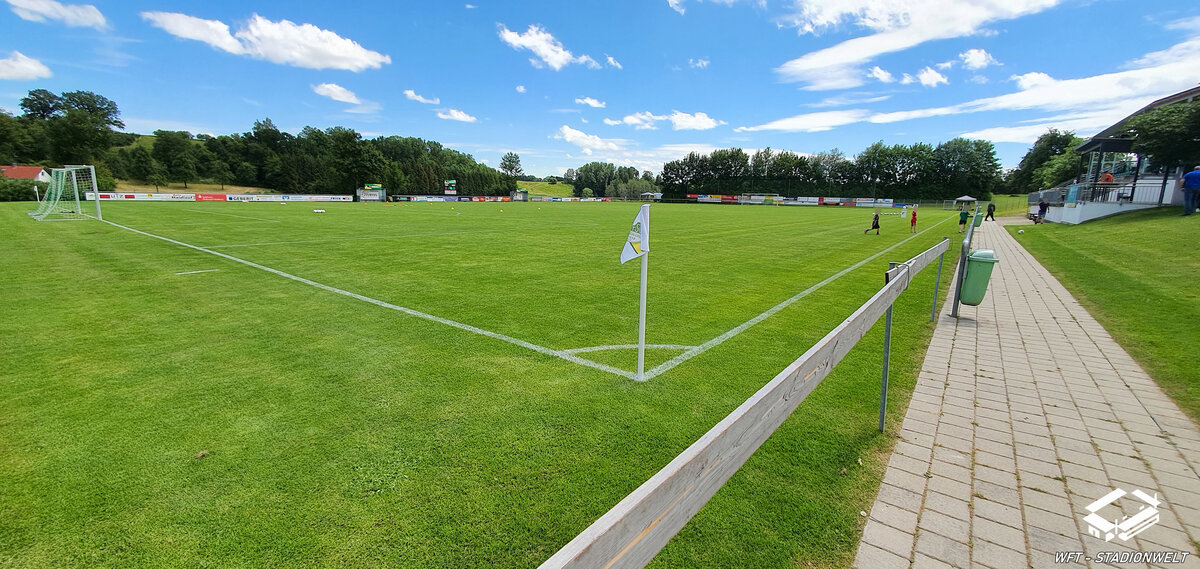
854, 220, 1200, 569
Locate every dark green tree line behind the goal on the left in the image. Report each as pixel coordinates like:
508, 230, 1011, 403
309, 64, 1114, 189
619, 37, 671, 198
0, 89, 516, 196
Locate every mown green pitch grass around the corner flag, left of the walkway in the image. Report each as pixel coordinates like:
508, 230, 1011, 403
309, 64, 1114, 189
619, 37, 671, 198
0, 202, 954, 568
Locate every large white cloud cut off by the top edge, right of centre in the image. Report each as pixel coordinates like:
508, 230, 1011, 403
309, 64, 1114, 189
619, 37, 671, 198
775, 0, 1060, 90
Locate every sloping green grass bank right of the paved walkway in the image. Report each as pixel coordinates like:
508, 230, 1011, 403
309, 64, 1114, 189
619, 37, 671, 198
1008, 208, 1200, 421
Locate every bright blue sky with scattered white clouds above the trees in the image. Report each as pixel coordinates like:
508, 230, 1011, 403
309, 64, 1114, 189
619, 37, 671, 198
0, 0, 1200, 175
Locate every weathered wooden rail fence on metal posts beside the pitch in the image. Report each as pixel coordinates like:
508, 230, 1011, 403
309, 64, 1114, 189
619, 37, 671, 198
540, 238, 950, 569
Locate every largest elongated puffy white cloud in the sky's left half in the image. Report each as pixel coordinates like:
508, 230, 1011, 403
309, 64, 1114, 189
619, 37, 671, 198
142, 12, 391, 72
